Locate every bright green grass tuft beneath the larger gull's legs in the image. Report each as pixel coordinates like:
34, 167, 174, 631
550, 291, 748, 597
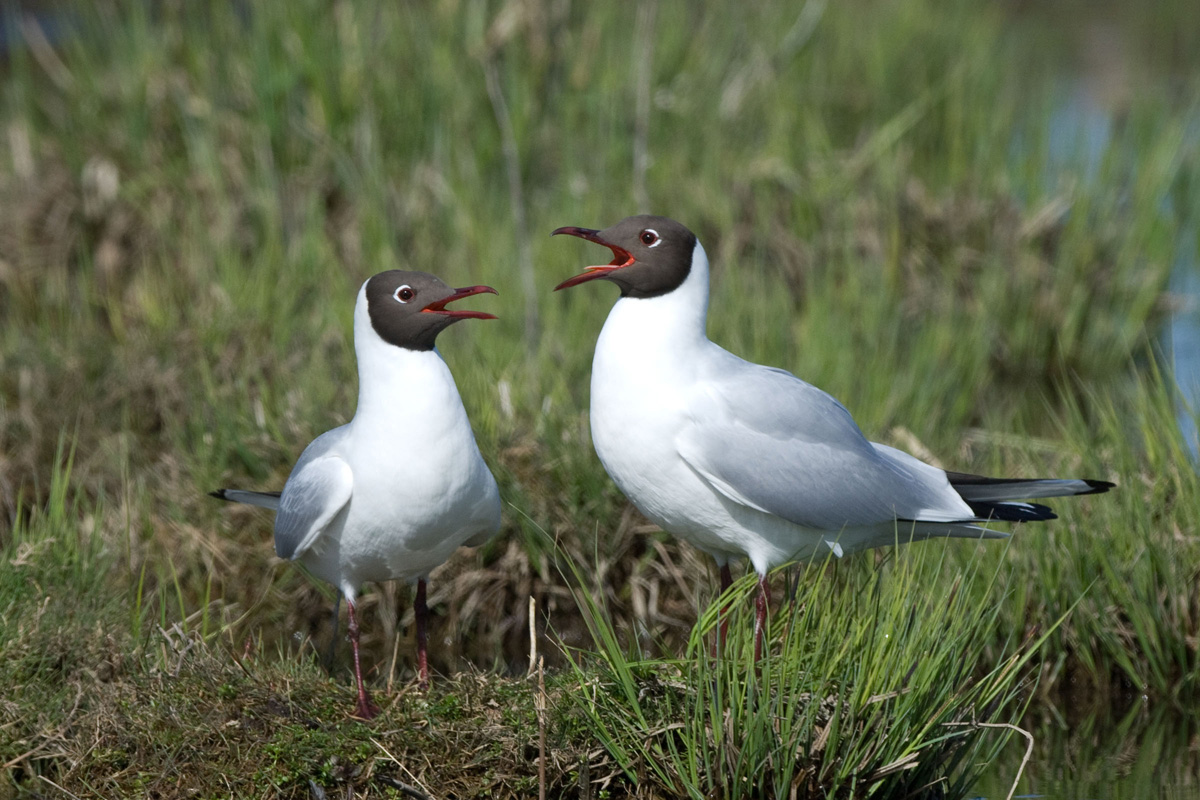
574, 545, 1038, 799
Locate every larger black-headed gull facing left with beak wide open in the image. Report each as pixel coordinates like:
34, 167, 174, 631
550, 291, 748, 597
554, 216, 1112, 651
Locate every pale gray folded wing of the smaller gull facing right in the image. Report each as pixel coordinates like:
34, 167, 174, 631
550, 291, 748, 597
275, 428, 354, 559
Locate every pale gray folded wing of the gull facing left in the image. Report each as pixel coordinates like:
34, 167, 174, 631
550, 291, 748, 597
676, 359, 973, 531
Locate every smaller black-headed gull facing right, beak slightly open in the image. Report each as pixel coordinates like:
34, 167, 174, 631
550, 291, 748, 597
212, 270, 500, 718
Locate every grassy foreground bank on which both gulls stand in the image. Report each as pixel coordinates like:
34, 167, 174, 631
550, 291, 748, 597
0, 471, 1040, 799
